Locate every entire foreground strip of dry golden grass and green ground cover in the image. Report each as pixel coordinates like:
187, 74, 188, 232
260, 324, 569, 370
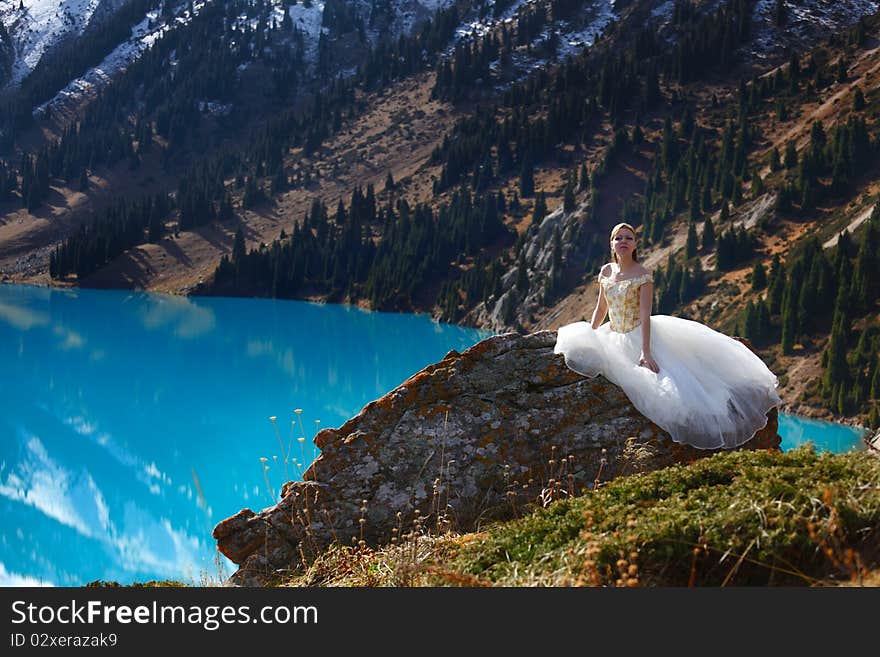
282, 447, 880, 587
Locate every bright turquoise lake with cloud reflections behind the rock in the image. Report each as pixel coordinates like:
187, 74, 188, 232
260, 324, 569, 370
0, 285, 862, 586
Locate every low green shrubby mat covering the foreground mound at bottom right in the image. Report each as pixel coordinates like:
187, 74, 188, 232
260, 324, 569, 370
453, 447, 880, 586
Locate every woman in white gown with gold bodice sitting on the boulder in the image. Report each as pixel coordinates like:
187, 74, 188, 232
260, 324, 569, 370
553, 223, 782, 449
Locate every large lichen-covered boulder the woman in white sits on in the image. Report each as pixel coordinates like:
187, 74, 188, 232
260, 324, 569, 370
213, 331, 780, 585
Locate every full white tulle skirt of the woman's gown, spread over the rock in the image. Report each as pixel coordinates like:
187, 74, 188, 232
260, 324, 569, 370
553, 315, 782, 449
